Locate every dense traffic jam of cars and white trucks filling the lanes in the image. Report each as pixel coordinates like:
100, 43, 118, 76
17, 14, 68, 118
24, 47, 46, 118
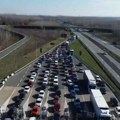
5, 35, 118, 120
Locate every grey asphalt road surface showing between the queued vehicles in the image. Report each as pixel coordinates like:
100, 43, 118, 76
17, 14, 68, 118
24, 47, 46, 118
0, 39, 118, 120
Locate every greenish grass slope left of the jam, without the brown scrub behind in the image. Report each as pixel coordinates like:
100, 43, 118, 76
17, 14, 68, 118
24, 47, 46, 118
0, 38, 65, 79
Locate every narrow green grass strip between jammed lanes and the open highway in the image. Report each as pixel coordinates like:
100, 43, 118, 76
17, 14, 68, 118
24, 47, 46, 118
71, 40, 120, 100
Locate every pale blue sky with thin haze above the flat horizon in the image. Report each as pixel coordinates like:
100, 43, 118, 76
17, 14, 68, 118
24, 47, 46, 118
0, 0, 120, 17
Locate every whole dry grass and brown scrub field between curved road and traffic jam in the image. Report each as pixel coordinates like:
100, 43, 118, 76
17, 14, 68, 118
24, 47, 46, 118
0, 29, 67, 79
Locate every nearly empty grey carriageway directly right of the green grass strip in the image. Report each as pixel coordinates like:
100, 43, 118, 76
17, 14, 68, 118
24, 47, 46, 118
75, 32, 120, 83
